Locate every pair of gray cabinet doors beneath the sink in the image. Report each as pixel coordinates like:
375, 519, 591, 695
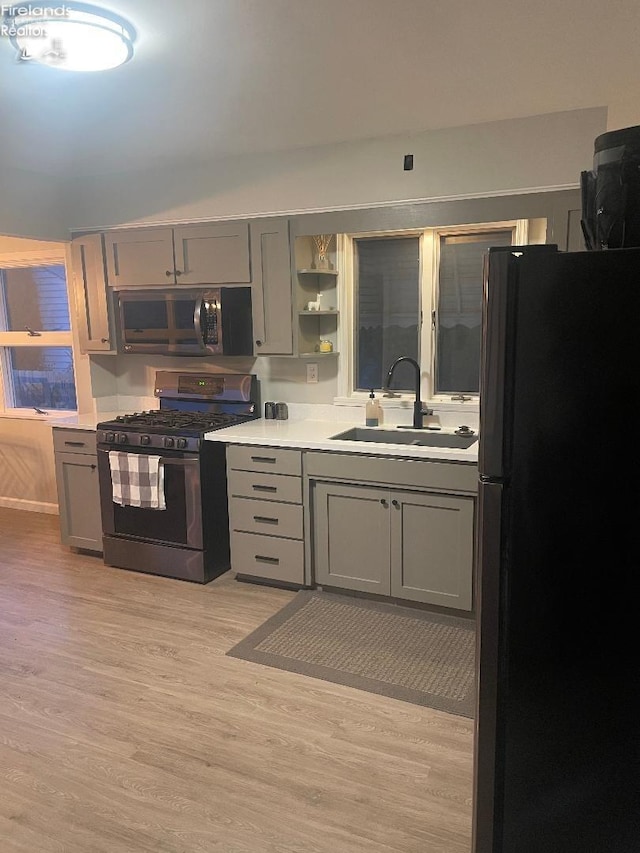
312, 462, 475, 610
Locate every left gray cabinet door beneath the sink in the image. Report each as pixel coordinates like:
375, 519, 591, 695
313, 482, 390, 595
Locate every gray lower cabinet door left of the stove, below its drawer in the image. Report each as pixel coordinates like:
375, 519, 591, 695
55, 453, 102, 551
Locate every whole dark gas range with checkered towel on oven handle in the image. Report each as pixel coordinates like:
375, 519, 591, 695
97, 371, 260, 583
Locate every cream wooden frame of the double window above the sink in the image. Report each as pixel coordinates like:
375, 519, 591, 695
334, 219, 529, 410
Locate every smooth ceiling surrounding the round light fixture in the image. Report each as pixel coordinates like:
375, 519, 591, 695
0, 0, 640, 175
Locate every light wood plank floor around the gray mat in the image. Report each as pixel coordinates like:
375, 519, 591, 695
0, 509, 473, 853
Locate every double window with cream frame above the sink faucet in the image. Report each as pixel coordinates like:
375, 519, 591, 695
339, 220, 528, 403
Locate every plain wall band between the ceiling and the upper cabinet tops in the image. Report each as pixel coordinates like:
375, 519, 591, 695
68, 107, 606, 230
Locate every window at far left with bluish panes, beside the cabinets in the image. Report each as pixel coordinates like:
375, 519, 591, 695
0, 253, 77, 414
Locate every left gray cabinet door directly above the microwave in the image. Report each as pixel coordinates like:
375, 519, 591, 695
105, 228, 176, 287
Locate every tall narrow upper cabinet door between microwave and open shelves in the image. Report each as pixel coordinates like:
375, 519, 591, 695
251, 219, 293, 355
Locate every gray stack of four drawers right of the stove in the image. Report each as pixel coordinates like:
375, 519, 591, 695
227, 445, 304, 586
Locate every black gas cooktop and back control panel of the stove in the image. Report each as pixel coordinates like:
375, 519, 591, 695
97, 371, 260, 452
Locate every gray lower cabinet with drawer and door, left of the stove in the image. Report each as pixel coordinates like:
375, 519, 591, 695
53, 427, 102, 552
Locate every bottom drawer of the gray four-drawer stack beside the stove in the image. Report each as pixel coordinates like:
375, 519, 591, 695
231, 532, 304, 585
